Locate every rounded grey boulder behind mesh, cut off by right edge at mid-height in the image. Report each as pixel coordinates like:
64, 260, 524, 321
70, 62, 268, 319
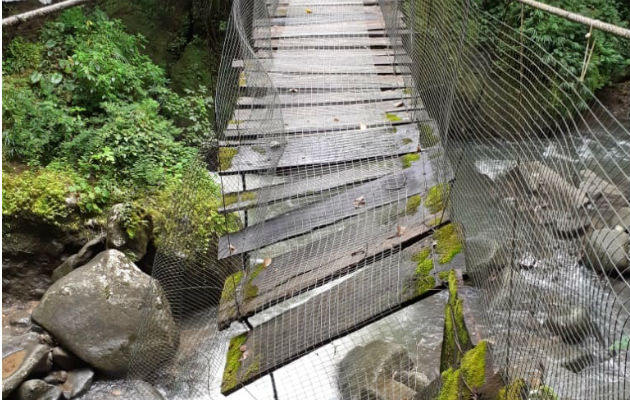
585, 228, 630, 274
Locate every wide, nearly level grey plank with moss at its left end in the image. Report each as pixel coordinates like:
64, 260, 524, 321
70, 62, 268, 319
221, 124, 420, 174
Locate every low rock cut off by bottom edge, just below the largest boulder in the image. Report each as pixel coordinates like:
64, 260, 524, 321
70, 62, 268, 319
76, 380, 165, 400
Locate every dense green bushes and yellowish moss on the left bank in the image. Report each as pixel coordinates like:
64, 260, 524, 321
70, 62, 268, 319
2, 8, 235, 250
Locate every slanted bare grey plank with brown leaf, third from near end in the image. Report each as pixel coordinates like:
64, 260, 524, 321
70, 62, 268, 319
218, 156, 433, 259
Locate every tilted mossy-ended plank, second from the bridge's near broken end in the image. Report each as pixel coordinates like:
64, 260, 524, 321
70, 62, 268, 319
219, 155, 449, 328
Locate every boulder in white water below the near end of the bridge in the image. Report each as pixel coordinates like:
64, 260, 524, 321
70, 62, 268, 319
338, 340, 415, 400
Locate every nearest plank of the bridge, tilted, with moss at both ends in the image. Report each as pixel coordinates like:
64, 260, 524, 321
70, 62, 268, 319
221, 225, 464, 394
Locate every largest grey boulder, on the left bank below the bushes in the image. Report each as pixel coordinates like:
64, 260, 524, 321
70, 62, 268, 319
32, 250, 179, 376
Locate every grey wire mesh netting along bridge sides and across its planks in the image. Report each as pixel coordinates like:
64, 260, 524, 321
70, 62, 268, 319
130, 0, 630, 399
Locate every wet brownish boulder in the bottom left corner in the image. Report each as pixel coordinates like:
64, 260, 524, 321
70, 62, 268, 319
2, 332, 52, 399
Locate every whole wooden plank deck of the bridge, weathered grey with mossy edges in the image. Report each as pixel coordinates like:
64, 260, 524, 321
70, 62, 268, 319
219, 0, 462, 393
